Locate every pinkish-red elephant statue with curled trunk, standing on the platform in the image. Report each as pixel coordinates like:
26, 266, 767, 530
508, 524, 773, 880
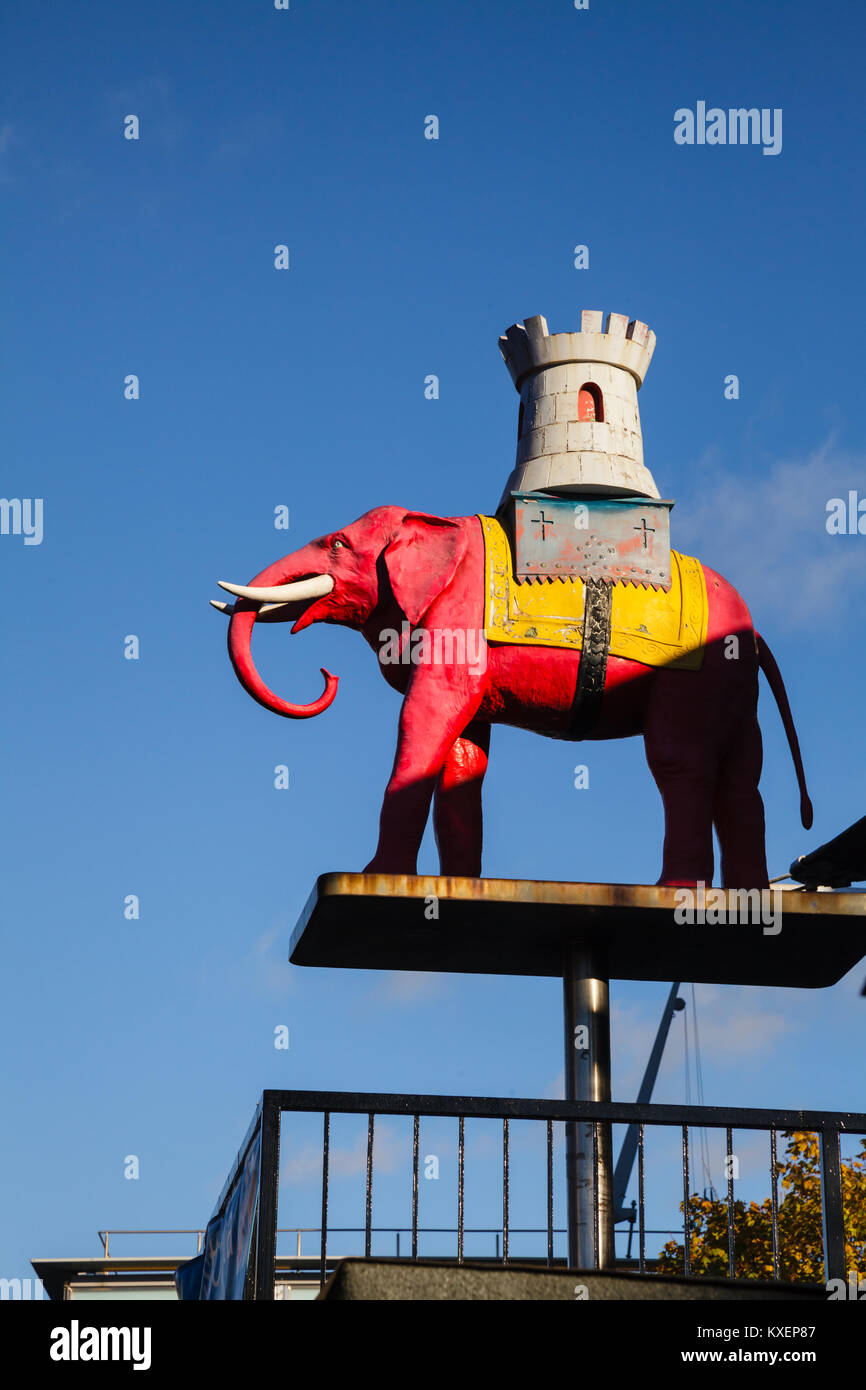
214, 506, 812, 888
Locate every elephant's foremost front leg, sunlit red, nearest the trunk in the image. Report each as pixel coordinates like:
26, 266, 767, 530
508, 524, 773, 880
366, 666, 481, 873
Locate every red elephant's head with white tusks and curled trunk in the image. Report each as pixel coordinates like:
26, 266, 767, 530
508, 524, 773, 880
211, 507, 466, 719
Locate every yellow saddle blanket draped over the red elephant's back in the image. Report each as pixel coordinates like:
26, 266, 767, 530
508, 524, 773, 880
478, 516, 708, 671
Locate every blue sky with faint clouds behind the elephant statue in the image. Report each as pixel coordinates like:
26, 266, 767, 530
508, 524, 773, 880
0, 0, 866, 1276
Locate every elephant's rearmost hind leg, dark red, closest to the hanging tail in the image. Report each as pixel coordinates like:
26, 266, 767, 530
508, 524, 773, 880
713, 713, 769, 888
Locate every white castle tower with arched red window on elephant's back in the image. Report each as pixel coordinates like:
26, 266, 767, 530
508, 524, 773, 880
499, 309, 659, 506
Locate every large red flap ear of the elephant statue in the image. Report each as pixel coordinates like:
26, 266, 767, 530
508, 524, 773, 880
384, 512, 467, 627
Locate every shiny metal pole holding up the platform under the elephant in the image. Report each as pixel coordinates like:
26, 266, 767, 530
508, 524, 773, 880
563, 945, 614, 1269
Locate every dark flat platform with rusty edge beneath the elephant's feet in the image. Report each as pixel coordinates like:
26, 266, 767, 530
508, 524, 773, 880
289, 873, 866, 988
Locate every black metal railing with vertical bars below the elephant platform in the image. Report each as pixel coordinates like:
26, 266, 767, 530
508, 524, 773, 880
214, 1091, 866, 1300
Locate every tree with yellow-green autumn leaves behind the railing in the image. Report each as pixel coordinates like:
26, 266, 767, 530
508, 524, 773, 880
657, 1130, 866, 1284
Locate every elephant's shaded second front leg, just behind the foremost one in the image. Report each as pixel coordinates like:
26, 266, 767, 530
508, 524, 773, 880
434, 723, 491, 878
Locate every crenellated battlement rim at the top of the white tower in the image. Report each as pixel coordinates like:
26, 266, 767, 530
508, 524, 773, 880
499, 309, 656, 391
